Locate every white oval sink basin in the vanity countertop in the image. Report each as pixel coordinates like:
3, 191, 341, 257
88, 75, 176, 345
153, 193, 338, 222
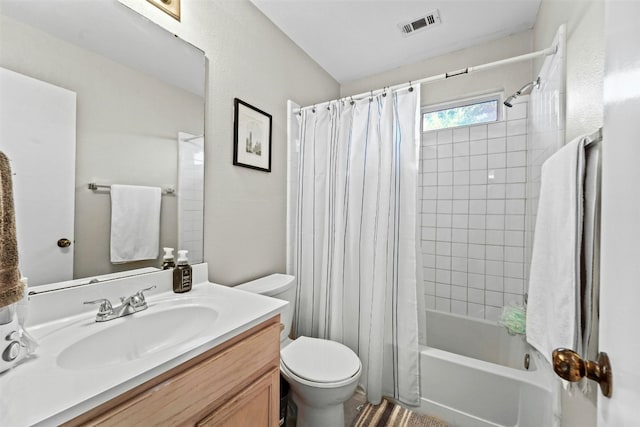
56, 303, 218, 370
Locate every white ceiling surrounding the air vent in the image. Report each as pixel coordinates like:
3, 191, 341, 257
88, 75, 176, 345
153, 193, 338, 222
251, 0, 540, 83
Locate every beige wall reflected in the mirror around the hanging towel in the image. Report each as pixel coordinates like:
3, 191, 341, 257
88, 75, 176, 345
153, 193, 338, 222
0, 15, 204, 278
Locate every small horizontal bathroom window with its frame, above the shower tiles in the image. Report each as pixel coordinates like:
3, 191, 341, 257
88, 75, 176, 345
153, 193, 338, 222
422, 94, 500, 132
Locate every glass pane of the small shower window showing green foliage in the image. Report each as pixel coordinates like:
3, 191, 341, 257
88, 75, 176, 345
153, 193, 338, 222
422, 99, 498, 132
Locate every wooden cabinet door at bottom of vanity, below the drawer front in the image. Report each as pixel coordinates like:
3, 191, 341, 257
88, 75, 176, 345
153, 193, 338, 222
196, 368, 280, 427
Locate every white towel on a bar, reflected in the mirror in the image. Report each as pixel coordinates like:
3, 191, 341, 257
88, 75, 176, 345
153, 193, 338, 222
111, 185, 162, 264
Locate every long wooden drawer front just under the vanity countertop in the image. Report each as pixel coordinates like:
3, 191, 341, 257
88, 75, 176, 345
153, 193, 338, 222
89, 323, 280, 426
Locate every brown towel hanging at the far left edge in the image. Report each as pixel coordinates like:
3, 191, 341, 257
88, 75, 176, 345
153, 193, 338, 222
0, 151, 23, 308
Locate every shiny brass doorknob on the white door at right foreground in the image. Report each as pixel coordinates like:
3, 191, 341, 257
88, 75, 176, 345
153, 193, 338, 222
552, 348, 613, 397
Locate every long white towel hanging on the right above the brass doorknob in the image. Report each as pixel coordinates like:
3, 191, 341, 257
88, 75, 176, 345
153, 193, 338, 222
526, 138, 584, 363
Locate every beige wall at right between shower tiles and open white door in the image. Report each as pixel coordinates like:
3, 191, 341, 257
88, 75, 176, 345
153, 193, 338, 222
534, 0, 604, 427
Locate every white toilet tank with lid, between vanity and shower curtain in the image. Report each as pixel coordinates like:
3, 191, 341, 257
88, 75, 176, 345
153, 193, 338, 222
235, 273, 296, 343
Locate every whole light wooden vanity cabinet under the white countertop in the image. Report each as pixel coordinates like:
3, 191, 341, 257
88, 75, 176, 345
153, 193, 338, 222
63, 315, 280, 427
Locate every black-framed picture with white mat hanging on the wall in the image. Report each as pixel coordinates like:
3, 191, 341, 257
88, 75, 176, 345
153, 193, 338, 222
233, 98, 271, 172
